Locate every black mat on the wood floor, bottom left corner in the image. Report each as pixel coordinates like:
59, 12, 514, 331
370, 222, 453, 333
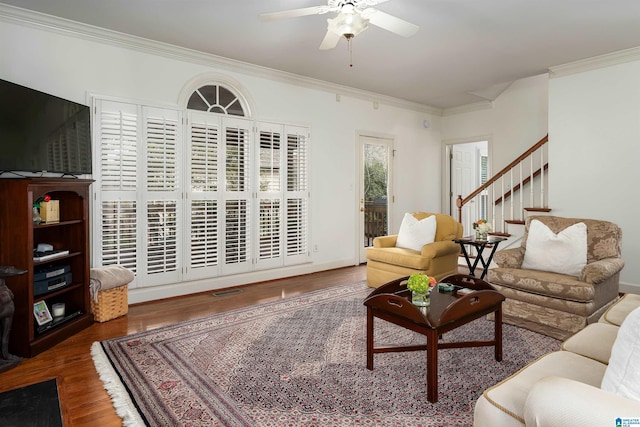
0, 379, 62, 427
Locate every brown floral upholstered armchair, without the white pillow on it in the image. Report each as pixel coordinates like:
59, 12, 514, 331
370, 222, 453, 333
487, 216, 624, 339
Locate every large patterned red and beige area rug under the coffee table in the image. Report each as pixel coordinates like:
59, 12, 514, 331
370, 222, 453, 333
92, 283, 560, 427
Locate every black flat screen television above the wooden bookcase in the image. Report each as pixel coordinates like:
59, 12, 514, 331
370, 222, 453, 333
0, 80, 91, 176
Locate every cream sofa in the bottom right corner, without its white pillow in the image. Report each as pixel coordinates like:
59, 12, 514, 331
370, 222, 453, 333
473, 294, 640, 427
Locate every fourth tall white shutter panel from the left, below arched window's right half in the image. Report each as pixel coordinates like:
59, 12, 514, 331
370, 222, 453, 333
222, 118, 253, 274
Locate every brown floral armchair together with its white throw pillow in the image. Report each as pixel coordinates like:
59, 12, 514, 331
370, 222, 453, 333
487, 216, 624, 339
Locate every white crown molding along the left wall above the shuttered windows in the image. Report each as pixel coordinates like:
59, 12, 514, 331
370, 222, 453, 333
0, 4, 443, 116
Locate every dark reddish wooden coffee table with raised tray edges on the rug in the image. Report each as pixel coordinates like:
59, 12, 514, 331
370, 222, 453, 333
364, 274, 504, 403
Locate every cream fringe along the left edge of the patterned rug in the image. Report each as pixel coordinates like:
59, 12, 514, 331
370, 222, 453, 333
91, 341, 146, 427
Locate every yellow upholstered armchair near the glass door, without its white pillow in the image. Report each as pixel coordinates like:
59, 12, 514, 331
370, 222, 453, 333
367, 212, 462, 288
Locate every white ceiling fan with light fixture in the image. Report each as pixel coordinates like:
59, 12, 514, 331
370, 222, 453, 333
260, 0, 419, 50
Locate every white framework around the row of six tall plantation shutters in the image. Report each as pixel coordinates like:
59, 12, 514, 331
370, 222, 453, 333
92, 92, 311, 288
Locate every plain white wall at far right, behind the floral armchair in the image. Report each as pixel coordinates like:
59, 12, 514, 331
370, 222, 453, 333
549, 60, 640, 293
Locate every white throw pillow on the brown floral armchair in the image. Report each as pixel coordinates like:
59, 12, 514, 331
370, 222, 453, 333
522, 219, 587, 276
